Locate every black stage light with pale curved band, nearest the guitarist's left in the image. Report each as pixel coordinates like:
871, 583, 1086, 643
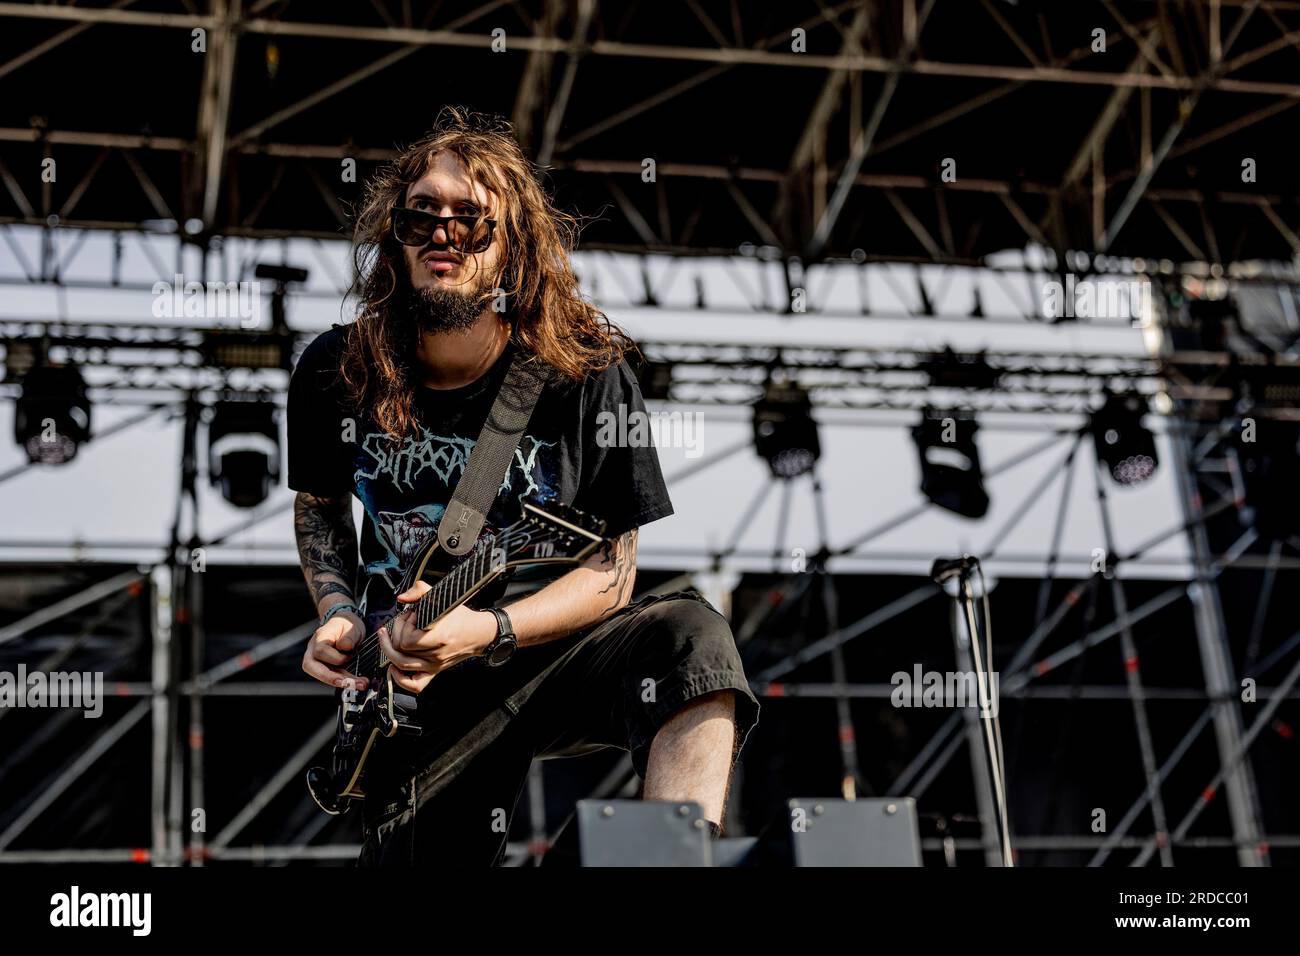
208, 401, 280, 507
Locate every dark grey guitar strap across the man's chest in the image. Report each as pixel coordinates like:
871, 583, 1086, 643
438, 350, 551, 557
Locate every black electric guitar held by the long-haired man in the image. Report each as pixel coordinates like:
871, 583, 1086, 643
307, 498, 606, 814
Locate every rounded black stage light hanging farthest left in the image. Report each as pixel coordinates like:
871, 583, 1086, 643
13, 365, 90, 464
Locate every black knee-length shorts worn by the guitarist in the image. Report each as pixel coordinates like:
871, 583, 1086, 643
358, 589, 759, 866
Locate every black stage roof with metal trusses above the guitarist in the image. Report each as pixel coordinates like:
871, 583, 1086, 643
0, 0, 1300, 263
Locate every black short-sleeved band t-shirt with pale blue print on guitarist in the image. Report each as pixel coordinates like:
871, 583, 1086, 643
289, 325, 672, 613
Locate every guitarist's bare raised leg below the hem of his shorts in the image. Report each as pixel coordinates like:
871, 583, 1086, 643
644, 691, 736, 826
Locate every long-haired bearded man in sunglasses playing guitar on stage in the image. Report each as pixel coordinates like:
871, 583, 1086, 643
289, 108, 758, 865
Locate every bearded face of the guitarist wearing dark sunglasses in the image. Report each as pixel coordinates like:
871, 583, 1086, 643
402, 152, 501, 332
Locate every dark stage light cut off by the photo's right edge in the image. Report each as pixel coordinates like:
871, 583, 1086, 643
1236, 418, 1300, 541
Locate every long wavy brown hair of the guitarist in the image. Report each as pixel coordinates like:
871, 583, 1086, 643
339, 107, 636, 438
